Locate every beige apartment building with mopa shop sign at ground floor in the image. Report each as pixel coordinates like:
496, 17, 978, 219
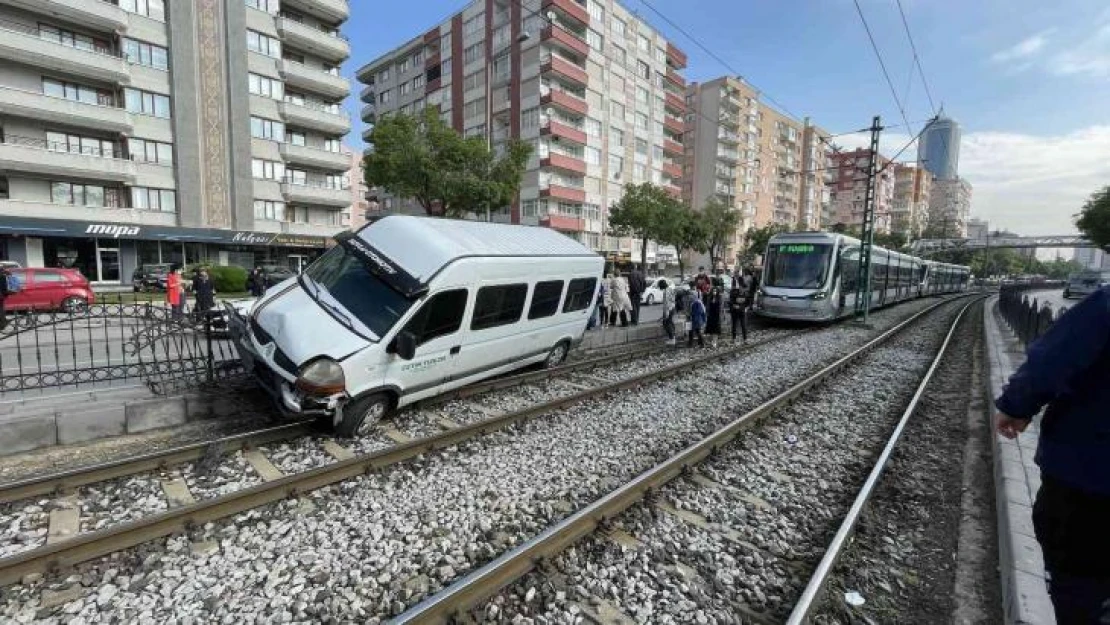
0, 0, 351, 284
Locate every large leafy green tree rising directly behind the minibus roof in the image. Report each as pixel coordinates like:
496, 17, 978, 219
364, 108, 532, 216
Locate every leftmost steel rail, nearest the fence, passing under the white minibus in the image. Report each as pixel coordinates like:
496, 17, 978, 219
0, 343, 670, 504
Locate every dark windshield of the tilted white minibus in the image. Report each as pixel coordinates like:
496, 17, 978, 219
304, 245, 412, 336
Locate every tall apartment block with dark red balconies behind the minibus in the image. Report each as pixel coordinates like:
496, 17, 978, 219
357, 0, 686, 262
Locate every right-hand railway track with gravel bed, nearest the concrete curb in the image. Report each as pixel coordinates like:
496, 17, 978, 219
395, 298, 981, 624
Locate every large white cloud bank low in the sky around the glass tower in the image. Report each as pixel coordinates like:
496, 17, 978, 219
835, 125, 1110, 234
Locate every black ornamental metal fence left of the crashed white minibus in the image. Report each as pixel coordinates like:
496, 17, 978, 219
0, 295, 242, 395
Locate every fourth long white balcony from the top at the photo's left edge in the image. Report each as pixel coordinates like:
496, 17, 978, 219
0, 134, 135, 183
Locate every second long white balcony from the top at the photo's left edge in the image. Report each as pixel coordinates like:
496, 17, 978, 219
0, 20, 131, 84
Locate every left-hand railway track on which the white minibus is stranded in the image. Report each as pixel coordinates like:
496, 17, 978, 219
0, 321, 797, 585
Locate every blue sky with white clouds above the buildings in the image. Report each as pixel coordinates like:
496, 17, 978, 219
345, 0, 1110, 234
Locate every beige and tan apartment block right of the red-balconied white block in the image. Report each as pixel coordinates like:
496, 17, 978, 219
683, 77, 828, 259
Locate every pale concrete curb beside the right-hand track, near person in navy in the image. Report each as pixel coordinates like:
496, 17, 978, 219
983, 295, 1056, 625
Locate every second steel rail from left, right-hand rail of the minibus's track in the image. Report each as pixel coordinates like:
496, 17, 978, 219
0, 319, 790, 587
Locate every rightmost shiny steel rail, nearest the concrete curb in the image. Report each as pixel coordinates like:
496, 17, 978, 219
786, 300, 981, 625
